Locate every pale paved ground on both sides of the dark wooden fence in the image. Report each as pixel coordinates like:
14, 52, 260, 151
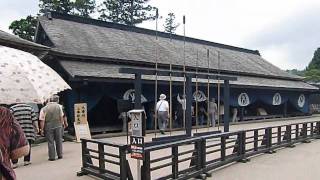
16, 116, 320, 180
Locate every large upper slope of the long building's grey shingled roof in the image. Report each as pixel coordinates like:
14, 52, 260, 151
39, 13, 300, 79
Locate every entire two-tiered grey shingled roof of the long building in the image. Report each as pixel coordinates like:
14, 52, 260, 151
39, 13, 317, 90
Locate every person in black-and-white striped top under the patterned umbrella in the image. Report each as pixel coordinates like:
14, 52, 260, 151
10, 103, 39, 168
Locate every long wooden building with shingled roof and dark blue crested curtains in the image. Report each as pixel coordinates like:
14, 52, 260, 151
36, 13, 318, 131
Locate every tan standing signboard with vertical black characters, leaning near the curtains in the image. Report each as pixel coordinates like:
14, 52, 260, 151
74, 103, 91, 142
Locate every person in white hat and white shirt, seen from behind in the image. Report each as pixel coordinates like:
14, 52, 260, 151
156, 94, 169, 134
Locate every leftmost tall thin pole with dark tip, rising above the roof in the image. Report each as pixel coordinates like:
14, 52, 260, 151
154, 9, 159, 138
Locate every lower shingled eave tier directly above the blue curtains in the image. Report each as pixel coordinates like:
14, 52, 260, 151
60, 60, 318, 90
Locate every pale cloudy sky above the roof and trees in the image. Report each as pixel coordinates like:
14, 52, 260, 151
0, 0, 320, 69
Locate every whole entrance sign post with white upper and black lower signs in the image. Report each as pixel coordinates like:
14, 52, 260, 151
129, 109, 145, 180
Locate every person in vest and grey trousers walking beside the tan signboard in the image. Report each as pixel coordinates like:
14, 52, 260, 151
39, 95, 64, 161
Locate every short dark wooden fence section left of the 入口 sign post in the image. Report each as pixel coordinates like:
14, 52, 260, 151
78, 139, 133, 180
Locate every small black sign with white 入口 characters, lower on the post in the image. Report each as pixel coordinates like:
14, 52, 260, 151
130, 136, 144, 160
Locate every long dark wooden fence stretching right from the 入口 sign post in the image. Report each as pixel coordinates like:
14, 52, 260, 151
141, 121, 320, 180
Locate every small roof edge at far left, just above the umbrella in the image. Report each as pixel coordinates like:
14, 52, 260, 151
0, 30, 49, 51
